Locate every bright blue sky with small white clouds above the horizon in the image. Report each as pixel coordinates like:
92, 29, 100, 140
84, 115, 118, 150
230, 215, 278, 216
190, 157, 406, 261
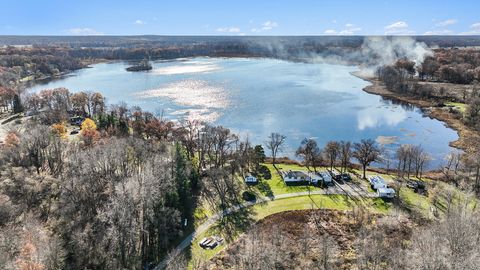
0, 0, 480, 35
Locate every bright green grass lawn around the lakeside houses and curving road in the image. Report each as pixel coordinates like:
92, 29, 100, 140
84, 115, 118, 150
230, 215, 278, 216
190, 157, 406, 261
189, 164, 470, 268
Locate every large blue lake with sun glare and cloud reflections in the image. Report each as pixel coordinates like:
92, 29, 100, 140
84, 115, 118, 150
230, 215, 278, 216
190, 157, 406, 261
27, 58, 458, 166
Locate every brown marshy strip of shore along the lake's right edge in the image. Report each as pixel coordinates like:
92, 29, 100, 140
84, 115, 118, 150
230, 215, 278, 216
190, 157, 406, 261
351, 72, 480, 153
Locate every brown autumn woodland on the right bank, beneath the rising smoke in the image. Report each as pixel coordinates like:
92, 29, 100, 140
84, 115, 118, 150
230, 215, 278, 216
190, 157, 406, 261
375, 49, 480, 129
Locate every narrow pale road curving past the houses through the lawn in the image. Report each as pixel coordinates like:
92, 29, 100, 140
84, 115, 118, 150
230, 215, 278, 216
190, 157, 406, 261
154, 185, 377, 270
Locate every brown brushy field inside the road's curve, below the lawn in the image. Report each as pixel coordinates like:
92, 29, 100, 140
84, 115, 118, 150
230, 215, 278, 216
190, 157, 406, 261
207, 209, 413, 269
